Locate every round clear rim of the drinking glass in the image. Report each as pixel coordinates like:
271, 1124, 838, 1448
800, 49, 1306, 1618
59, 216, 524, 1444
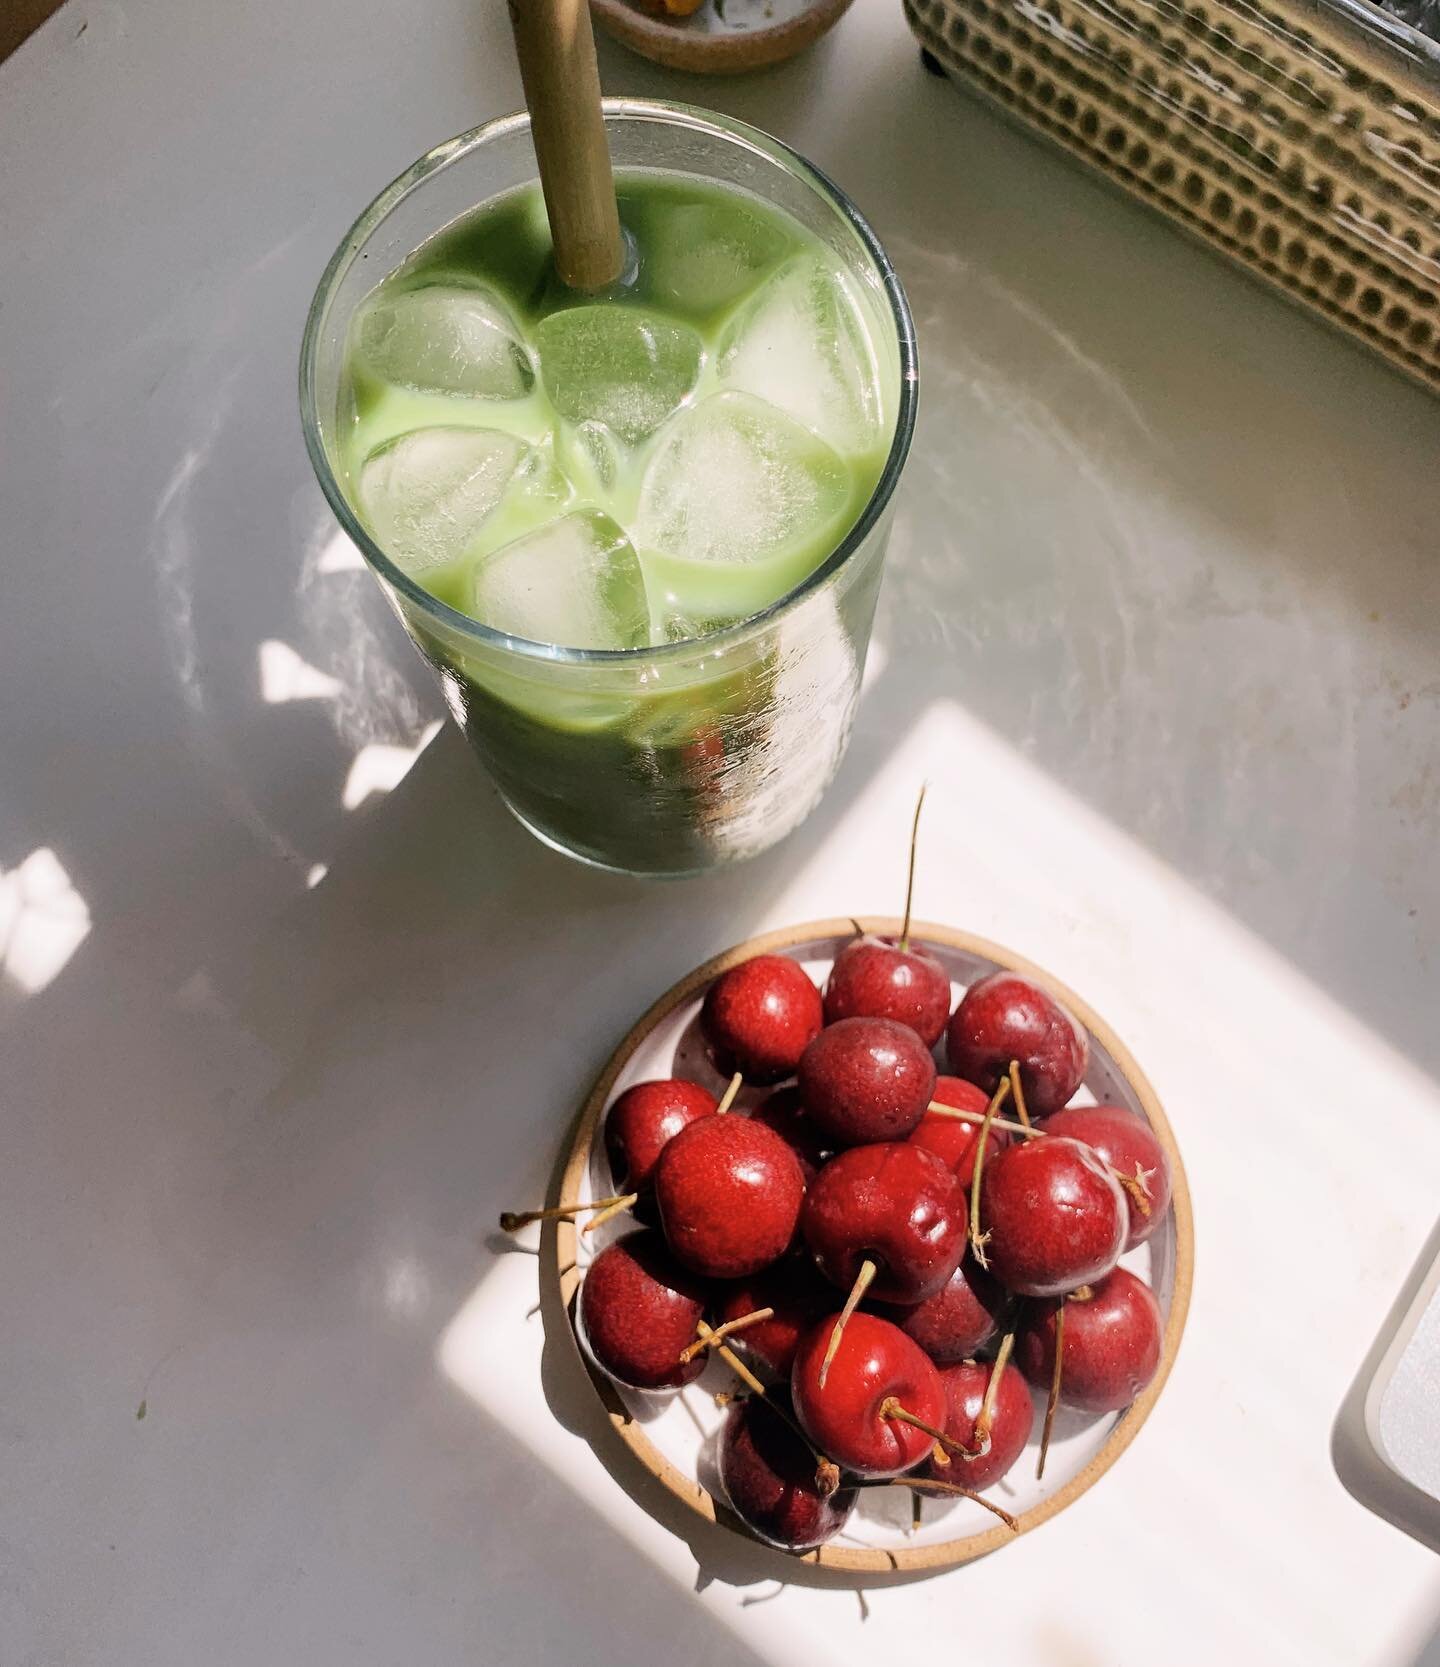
300, 97, 918, 667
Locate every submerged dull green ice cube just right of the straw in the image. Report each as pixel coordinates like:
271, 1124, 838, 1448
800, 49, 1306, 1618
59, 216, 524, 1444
642, 202, 787, 313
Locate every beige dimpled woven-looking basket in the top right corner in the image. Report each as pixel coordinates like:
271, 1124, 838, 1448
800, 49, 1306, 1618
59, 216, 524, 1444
905, 0, 1440, 388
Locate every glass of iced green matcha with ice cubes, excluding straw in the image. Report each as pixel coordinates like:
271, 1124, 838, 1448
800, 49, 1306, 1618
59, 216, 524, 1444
300, 98, 917, 875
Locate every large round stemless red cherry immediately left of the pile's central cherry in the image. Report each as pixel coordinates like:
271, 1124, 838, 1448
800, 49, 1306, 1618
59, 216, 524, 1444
655, 1114, 805, 1279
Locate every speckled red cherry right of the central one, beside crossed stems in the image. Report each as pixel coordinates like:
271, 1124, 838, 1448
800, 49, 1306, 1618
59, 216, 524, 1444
980, 1124, 1130, 1297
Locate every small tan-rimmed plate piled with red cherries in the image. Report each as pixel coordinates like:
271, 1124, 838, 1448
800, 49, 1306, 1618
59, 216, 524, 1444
502, 893, 1193, 1570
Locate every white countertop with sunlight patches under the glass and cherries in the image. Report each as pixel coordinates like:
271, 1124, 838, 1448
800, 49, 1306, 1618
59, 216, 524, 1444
0, 0, 1440, 1667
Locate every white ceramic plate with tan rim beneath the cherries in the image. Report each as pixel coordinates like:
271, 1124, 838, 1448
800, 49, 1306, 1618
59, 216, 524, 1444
540, 919, 1195, 1572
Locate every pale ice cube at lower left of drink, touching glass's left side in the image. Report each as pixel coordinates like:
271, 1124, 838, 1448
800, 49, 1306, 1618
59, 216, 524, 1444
357, 428, 543, 573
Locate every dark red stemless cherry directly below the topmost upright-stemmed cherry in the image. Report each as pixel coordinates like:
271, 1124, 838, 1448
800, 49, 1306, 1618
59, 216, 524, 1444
800, 1019, 935, 1145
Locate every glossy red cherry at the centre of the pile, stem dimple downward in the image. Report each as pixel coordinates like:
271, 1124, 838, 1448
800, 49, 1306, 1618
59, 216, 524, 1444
800, 1140, 970, 1304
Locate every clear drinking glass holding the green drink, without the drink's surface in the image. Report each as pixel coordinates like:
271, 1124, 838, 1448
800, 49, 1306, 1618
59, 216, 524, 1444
300, 98, 917, 875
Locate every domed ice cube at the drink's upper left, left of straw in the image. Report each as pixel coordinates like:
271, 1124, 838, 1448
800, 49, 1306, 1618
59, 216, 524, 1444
355, 283, 535, 400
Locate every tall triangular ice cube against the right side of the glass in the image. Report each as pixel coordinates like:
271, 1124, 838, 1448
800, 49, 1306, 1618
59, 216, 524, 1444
718, 255, 880, 453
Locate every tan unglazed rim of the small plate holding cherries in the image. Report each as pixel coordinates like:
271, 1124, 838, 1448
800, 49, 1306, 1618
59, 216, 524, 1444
540, 915, 1195, 1574
